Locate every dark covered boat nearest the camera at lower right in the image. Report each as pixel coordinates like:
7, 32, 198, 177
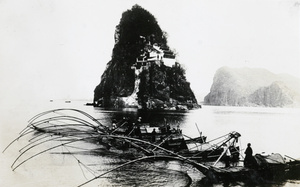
203, 153, 300, 185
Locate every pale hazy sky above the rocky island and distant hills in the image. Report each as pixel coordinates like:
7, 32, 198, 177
0, 0, 300, 102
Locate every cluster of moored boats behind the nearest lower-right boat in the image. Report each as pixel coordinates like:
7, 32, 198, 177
100, 119, 241, 161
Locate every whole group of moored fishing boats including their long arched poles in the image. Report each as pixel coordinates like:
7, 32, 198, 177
6, 109, 300, 185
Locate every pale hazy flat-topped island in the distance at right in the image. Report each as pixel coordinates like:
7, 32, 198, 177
204, 67, 300, 107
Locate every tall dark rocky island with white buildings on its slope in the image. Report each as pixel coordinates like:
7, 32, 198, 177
93, 5, 199, 110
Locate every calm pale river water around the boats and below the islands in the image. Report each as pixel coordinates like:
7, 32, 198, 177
0, 100, 300, 186
